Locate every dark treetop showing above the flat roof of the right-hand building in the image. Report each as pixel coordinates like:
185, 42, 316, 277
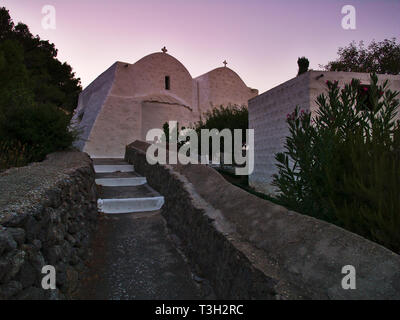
320, 38, 400, 74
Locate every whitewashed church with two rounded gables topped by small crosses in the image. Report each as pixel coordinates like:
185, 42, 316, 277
72, 47, 258, 158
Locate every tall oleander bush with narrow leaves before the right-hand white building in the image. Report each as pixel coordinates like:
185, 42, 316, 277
273, 74, 400, 252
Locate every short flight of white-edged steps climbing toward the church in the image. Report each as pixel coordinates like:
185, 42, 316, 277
93, 158, 164, 214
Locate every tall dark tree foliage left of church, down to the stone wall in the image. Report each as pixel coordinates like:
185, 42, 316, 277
0, 8, 81, 170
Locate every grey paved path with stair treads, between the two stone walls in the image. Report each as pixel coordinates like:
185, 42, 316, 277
75, 159, 212, 299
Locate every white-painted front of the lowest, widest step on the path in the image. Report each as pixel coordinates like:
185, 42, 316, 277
97, 196, 164, 214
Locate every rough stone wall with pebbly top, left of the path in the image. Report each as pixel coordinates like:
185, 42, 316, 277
0, 151, 97, 300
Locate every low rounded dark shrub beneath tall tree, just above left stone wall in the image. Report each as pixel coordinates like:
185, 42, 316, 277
0, 99, 77, 169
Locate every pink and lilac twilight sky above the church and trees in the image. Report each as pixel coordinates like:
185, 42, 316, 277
0, 0, 400, 93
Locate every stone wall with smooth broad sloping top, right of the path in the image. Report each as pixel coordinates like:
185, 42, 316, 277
125, 141, 400, 299
